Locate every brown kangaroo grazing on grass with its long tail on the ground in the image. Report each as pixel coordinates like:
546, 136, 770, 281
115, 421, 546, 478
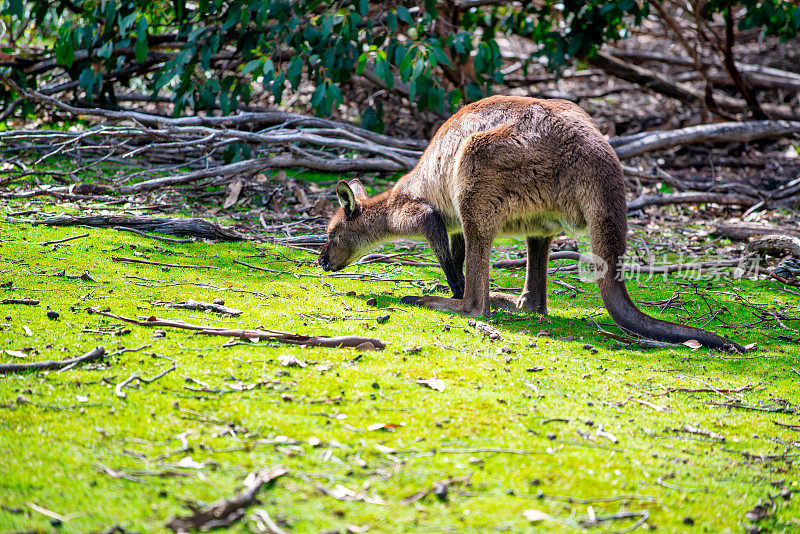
319, 96, 744, 352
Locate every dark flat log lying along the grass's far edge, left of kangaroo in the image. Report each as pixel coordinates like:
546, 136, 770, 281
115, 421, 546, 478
25, 215, 244, 241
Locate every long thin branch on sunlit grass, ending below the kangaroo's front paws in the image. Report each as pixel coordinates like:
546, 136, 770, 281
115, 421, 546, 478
89, 308, 386, 350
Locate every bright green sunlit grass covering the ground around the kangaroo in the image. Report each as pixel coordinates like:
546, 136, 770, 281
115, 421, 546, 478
0, 204, 800, 533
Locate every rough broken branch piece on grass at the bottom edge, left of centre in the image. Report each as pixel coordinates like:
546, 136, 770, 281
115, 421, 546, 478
166, 465, 288, 534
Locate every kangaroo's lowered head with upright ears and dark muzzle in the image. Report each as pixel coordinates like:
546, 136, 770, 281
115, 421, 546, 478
319, 179, 375, 271
